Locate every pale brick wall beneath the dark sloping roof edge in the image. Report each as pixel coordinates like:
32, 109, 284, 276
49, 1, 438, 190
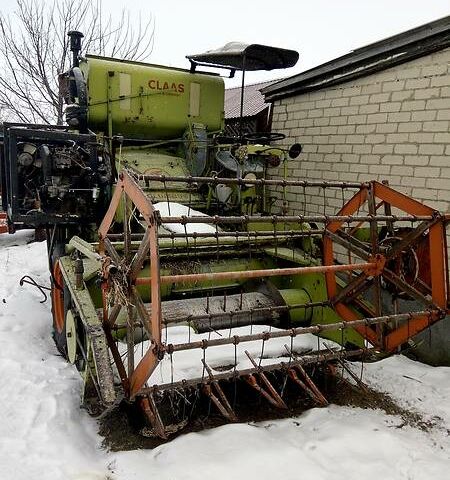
272, 49, 450, 213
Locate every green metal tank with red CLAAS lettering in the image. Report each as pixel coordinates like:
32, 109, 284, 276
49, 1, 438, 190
80, 56, 224, 139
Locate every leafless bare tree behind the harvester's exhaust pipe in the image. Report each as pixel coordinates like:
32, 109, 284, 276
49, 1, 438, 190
0, 0, 154, 124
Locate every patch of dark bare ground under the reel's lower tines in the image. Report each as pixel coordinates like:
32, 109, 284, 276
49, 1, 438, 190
99, 369, 441, 451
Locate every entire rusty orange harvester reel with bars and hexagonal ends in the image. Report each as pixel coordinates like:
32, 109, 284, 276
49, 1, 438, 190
92, 170, 448, 438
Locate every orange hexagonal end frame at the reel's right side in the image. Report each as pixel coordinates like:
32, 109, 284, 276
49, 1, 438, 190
323, 181, 448, 352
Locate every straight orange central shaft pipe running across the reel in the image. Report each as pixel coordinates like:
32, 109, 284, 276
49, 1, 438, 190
135, 262, 377, 285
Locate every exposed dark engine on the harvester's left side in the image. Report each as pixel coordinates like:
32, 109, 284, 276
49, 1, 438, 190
2, 124, 111, 227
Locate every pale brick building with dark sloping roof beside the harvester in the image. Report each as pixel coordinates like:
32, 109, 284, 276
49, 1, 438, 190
262, 16, 450, 365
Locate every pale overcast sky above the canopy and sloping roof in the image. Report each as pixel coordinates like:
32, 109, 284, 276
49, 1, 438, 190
0, 0, 450, 86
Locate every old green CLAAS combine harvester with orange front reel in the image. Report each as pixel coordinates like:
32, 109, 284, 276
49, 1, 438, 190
1, 32, 448, 438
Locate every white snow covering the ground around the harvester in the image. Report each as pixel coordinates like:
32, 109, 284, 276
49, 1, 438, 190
0, 232, 450, 480
